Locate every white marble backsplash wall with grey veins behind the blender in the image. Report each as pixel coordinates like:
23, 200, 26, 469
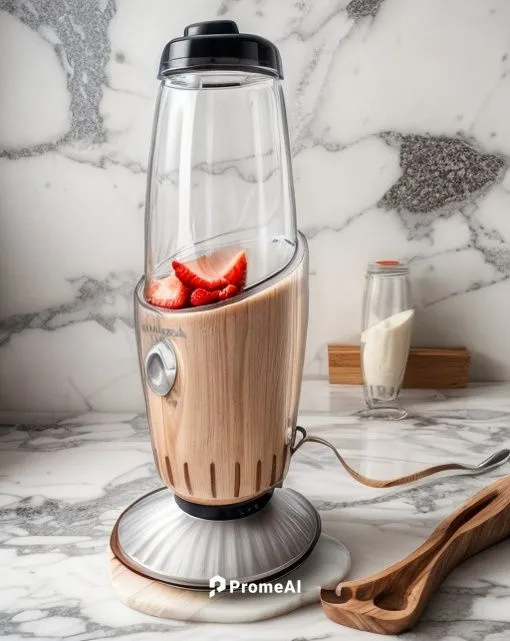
0, 0, 510, 411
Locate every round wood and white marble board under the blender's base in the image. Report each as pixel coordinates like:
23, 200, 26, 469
109, 534, 351, 623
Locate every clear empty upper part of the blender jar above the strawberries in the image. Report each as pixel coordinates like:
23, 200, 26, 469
145, 69, 297, 289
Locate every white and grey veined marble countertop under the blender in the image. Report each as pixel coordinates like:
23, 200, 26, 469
0, 381, 510, 641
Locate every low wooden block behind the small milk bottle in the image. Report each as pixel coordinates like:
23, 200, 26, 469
328, 345, 471, 389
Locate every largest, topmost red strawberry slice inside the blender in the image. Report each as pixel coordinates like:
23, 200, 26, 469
172, 249, 247, 291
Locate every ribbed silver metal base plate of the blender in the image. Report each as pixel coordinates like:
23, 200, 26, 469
110, 487, 321, 590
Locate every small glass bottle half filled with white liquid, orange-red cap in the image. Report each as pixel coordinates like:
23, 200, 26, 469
361, 260, 414, 420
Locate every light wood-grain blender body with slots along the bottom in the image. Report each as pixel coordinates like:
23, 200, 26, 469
135, 235, 308, 505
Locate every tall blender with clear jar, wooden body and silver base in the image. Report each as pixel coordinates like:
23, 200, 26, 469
111, 21, 321, 590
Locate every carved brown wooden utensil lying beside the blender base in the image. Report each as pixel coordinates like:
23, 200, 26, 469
321, 476, 510, 634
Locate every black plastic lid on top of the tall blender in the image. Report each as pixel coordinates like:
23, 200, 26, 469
159, 20, 283, 78
